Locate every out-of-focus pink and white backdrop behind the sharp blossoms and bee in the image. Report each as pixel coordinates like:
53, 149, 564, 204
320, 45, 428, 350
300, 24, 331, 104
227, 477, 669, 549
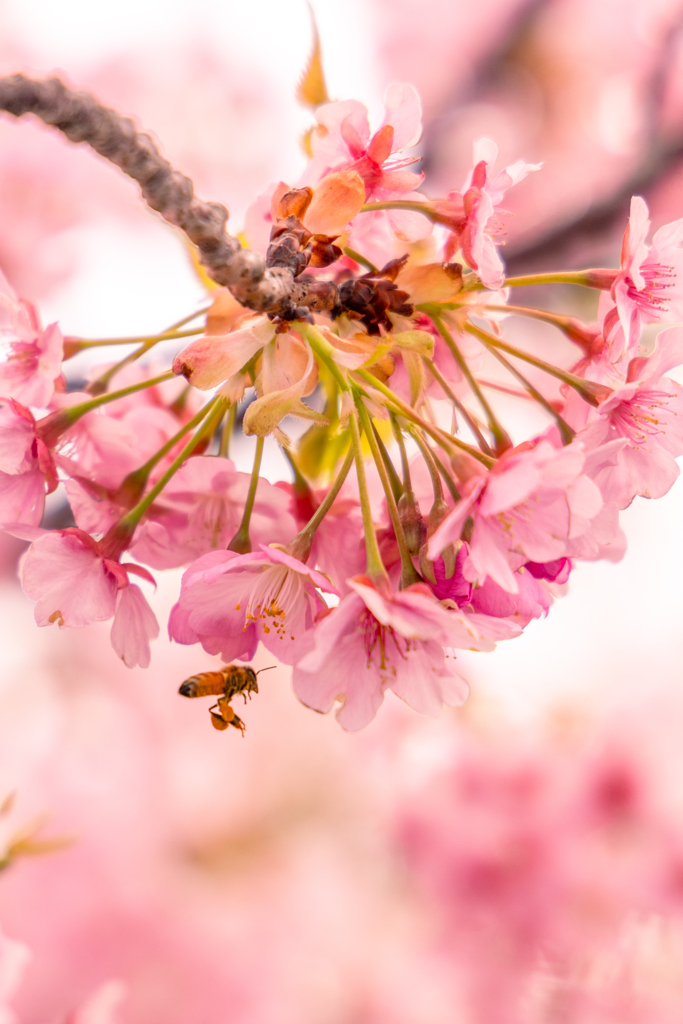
0, 0, 683, 1024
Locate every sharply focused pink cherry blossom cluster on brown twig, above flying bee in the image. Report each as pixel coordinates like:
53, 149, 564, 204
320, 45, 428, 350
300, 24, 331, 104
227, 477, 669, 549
0, 76, 683, 730
